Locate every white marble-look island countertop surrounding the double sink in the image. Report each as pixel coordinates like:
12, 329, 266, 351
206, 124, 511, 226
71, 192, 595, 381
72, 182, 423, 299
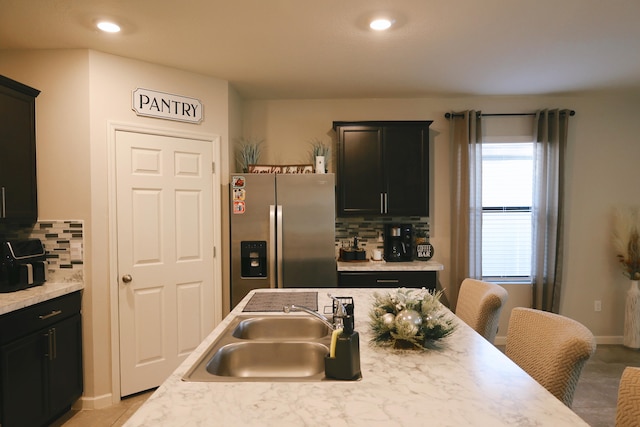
125, 289, 587, 427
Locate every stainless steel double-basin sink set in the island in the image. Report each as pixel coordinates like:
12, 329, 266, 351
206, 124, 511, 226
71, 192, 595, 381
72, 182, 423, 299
182, 315, 331, 382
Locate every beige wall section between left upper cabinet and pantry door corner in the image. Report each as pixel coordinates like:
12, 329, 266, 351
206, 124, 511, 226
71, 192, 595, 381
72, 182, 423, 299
0, 50, 91, 219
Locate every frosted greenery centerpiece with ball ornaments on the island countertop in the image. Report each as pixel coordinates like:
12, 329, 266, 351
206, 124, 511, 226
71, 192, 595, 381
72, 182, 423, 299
369, 288, 455, 350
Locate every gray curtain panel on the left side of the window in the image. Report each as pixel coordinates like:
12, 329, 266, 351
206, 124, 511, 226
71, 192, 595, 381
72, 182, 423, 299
448, 110, 482, 310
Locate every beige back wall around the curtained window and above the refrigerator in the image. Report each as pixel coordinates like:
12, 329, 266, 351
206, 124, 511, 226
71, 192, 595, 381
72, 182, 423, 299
244, 94, 640, 343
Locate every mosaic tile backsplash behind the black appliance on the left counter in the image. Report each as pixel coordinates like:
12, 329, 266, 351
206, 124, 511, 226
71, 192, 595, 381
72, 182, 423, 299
0, 220, 84, 281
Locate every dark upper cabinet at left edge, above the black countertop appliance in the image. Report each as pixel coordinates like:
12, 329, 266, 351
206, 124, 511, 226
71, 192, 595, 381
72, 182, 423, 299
0, 76, 40, 222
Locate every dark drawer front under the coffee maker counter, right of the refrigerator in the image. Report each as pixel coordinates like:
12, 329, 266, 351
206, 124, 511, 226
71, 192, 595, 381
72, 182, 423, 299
338, 271, 436, 289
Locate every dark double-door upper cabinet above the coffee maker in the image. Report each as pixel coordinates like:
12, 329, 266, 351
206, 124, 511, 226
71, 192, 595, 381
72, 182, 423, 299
333, 121, 432, 216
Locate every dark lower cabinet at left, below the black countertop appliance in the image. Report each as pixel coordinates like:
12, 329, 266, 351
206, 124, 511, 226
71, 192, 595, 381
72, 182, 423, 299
0, 292, 83, 427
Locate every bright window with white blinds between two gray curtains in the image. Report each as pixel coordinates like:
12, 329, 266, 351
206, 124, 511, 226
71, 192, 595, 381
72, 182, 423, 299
482, 142, 534, 281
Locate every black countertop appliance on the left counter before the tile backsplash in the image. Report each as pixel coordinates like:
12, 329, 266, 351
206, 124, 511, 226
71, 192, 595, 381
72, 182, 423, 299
0, 239, 47, 293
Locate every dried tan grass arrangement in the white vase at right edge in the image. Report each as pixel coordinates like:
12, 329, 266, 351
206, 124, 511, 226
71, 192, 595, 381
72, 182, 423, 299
613, 207, 640, 280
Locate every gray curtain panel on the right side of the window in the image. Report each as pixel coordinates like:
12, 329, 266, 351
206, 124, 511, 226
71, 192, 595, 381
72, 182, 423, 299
532, 109, 570, 313
